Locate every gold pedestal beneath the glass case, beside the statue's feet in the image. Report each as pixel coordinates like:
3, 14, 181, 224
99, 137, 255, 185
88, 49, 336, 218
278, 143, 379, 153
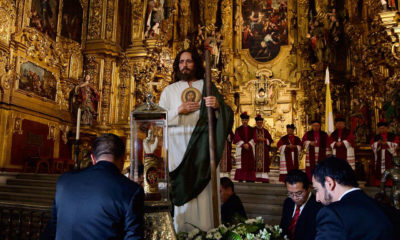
144, 201, 176, 240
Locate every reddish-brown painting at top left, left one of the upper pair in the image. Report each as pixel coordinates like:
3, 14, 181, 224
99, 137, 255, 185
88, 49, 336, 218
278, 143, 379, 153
30, 0, 59, 40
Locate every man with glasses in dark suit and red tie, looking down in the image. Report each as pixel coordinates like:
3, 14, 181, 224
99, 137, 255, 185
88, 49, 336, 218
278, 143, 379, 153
280, 169, 322, 240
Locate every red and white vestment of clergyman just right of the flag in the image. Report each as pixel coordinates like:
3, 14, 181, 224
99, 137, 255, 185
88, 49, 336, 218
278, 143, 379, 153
329, 128, 356, 170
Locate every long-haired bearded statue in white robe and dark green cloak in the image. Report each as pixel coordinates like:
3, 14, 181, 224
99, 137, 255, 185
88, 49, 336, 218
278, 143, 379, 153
159, 50, 233, 232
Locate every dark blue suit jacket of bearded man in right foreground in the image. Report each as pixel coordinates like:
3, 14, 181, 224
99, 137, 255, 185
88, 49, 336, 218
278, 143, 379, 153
315, 190, 394, 240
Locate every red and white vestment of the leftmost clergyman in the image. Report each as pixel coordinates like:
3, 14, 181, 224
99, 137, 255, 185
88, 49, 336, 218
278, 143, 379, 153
233, 126, 256, 182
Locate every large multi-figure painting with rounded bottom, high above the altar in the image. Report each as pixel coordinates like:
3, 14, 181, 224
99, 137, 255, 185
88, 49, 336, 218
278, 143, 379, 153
242, 0, 288, 62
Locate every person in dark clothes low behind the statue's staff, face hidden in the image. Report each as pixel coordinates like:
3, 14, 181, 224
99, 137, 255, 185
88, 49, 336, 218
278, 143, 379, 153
220, 177, 247, 225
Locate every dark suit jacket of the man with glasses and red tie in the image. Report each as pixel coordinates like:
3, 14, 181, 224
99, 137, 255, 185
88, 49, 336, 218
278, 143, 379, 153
280, 193, 322, 240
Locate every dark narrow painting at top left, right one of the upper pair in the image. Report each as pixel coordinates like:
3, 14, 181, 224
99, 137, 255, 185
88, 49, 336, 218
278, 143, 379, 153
61, 0, 83, 43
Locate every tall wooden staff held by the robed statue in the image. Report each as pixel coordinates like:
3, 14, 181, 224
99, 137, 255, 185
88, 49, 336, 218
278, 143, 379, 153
205, 50, 219, 227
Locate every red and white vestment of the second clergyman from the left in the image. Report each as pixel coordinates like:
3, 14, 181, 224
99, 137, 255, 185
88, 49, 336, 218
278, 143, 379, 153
255, 127, 273, 182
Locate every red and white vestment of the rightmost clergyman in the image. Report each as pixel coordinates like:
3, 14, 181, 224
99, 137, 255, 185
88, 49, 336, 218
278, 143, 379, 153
370, 132, 399, 186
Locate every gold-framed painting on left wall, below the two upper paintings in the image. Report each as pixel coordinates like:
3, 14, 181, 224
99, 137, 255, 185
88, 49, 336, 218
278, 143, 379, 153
19, 62, 57, 101
